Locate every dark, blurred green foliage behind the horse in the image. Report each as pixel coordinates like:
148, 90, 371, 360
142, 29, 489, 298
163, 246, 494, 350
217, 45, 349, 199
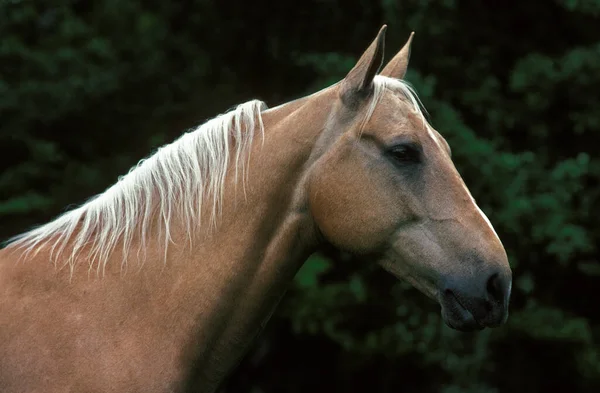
0, 0, 600, 393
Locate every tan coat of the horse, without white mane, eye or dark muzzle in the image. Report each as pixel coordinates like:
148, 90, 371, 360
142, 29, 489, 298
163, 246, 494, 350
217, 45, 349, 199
0, 26, 510, 393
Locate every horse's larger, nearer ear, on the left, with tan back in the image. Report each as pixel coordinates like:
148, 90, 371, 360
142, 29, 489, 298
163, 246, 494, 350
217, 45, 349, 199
341, 25, 387, 99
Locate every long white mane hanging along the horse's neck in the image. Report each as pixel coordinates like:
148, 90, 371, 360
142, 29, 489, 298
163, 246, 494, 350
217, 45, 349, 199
8, 100, 266, 271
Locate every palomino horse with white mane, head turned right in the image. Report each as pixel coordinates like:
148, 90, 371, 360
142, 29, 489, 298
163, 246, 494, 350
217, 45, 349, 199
0, 25, 512, 393
